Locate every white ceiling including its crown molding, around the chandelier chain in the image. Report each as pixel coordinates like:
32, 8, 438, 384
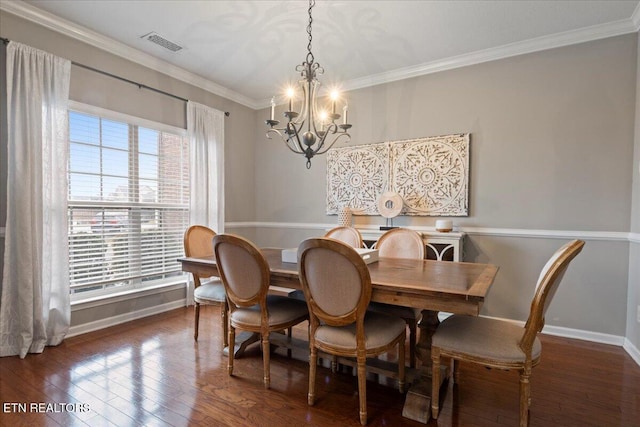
1, 0, 640, 108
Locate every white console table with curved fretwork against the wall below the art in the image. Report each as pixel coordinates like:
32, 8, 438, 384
356, 227, 465, 262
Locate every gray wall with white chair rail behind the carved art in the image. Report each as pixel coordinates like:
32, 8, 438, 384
256, 34, 637, 337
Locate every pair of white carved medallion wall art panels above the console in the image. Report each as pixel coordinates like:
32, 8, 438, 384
327, 133, 470, 216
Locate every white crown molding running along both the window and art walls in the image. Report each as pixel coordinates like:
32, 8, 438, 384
0, 1, 640, 110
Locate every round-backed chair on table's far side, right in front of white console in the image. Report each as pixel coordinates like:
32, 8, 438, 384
369, 228, 425, 368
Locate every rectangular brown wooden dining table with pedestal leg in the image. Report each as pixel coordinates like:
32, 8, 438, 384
178, 248, 498, 423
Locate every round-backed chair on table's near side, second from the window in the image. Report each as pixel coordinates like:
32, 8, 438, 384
213, 234, 309, 388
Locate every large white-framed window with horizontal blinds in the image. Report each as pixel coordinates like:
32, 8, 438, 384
68, 104, 189, 300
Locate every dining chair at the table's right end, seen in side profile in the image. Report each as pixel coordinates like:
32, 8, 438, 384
431, 240, 585, 426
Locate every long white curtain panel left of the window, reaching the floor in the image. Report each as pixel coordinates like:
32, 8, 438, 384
0, 42, 71, 358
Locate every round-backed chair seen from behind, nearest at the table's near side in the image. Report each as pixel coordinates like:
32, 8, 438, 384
298, 238, 406, 425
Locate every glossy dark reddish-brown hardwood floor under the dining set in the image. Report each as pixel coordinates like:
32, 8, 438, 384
0, 306, 640, 427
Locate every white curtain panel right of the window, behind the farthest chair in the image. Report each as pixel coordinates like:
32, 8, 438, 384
187, 101, 224, 305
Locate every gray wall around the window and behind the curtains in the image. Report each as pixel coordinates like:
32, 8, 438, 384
0, 12, 256, 327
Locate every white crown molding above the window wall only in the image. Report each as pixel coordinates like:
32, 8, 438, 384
0, 1, 259, 110
